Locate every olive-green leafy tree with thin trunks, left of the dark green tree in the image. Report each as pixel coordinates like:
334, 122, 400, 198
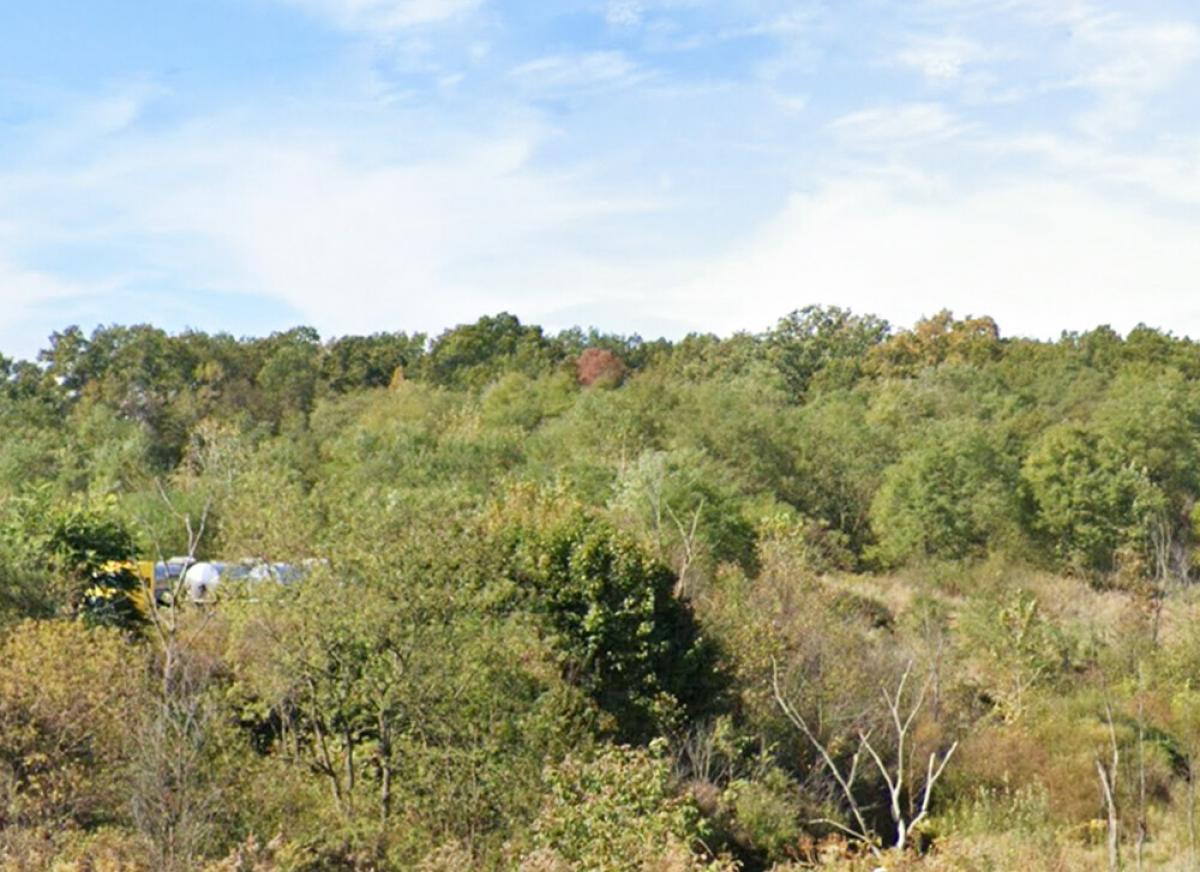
230, 519, 587, 868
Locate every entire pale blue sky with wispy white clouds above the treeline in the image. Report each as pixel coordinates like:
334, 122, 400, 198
0, 0, 1200, 356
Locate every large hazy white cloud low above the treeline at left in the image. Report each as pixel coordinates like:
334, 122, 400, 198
0, 97, 676, 348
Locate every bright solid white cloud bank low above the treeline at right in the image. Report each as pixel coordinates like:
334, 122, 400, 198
671, 179, 1200, 337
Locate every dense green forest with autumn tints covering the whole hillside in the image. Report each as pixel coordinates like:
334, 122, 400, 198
0, 307, 1200, 872
